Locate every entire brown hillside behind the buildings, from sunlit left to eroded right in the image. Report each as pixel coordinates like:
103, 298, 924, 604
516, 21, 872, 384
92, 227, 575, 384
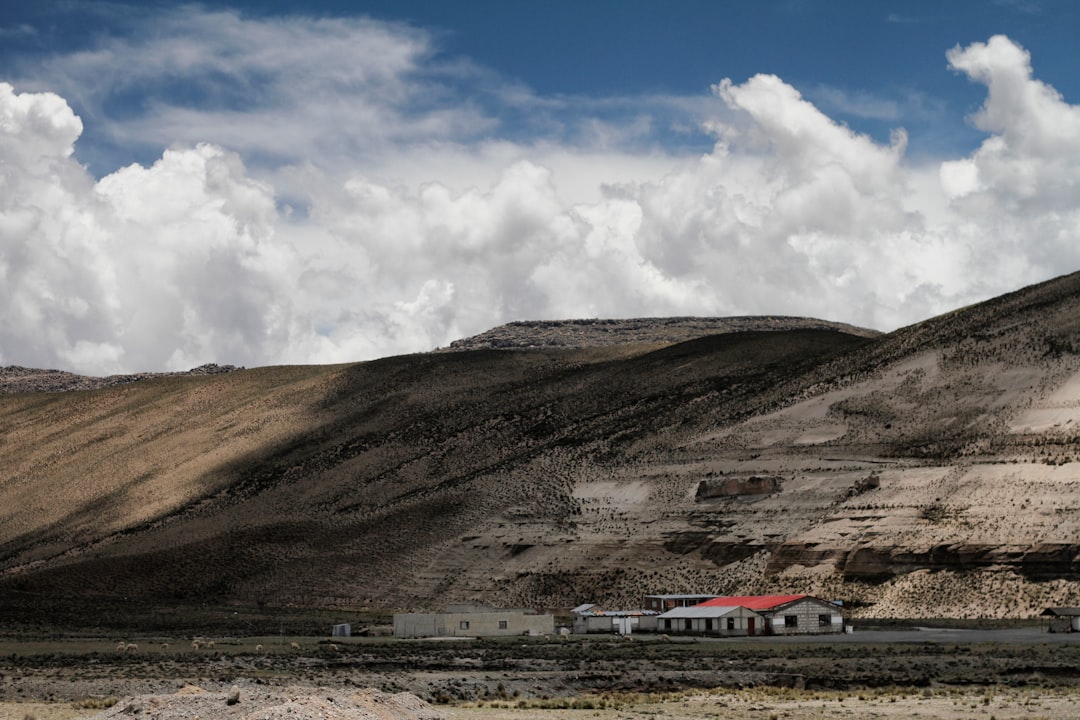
0, 275, 1080, 617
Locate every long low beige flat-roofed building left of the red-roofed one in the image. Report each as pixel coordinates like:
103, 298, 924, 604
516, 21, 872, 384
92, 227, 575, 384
394, 608, 555, 638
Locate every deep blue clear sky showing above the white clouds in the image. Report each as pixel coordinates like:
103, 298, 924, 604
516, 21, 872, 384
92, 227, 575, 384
0, 0, 1080, 174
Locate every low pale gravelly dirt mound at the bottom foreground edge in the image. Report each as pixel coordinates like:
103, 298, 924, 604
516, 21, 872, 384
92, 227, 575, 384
96, 685, 445, 720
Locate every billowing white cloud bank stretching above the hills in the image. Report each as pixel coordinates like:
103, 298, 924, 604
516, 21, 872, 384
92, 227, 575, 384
0, 21, 1080, 373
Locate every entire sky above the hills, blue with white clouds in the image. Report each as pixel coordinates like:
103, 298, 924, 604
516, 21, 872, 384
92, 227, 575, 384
0, 0, 1080, 375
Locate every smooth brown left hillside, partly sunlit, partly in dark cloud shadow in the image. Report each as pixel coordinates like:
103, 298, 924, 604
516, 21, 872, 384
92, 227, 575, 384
0, 330, 864, 604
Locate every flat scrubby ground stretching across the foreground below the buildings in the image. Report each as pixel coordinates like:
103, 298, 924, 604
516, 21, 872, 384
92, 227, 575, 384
0, 630, 1080, 720
